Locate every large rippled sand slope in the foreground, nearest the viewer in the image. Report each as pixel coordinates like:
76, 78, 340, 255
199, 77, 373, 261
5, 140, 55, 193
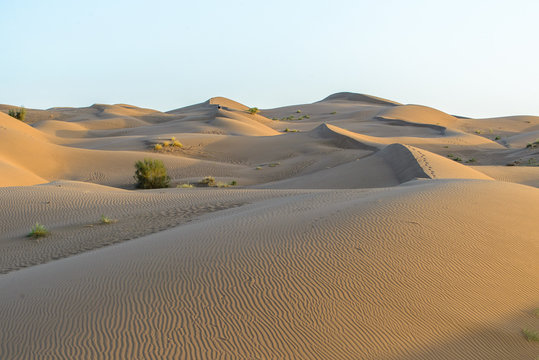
0, 180, 539, 359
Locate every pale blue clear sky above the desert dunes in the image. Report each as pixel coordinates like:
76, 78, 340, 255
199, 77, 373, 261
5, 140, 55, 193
0, 0, 539, 117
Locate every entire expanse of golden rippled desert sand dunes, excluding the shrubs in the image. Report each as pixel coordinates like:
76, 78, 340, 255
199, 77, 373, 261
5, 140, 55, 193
0, 93, 539, 360
